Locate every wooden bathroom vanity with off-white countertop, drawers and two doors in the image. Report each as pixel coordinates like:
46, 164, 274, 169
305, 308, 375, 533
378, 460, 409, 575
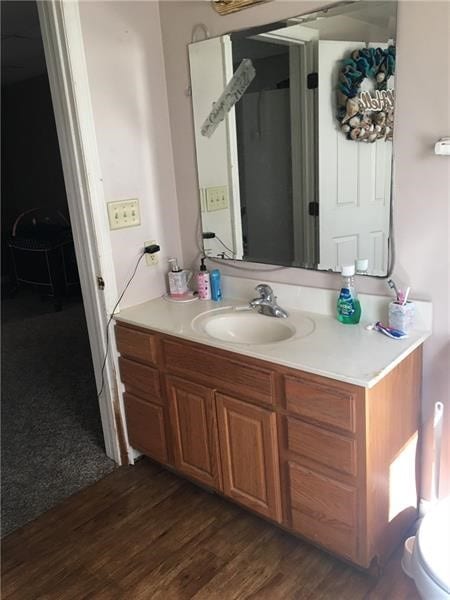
116, 286, 427, 568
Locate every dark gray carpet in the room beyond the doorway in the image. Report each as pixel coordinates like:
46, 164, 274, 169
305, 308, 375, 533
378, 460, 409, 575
1, 296, 115, 536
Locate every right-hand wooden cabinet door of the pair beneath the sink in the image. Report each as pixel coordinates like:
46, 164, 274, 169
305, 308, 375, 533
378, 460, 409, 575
216, 393, 281, 522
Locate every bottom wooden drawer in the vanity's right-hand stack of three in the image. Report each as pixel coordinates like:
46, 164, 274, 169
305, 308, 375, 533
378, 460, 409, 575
288, 462, 357, 558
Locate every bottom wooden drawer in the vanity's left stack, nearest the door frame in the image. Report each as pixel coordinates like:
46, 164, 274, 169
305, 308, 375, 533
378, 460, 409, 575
124, 394, 169, 463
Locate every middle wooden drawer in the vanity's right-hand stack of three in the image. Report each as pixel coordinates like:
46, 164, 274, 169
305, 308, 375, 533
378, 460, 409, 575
283, 417, 356, 476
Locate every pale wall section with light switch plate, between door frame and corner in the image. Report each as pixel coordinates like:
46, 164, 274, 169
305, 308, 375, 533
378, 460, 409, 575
79, 1, 181, 307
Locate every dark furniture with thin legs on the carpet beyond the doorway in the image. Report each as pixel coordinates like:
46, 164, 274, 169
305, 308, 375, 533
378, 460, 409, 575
8, 208, 79, 310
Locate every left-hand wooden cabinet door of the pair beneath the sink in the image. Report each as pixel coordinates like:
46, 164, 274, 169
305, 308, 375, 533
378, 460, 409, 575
167, 376, 221, 488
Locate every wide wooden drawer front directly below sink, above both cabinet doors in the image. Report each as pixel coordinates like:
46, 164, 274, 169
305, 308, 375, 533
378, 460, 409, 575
163, 340, 274, 404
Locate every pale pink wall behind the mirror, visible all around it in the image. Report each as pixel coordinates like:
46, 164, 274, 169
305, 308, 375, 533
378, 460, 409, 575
160, 0, 450, 495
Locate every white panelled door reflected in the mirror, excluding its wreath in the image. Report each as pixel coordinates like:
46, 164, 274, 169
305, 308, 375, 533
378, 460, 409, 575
319, 41, 392, 275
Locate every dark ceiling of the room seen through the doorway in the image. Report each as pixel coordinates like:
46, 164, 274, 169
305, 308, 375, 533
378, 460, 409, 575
1, 0, 46, 86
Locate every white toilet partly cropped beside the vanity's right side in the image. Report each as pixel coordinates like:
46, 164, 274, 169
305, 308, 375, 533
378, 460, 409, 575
402, 496, 450, 600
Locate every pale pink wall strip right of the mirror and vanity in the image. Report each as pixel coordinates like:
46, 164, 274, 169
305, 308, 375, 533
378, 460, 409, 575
394, 1, 450, 493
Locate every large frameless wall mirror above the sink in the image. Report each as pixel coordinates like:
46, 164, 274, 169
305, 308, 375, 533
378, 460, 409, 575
189, 0, 397, 276
